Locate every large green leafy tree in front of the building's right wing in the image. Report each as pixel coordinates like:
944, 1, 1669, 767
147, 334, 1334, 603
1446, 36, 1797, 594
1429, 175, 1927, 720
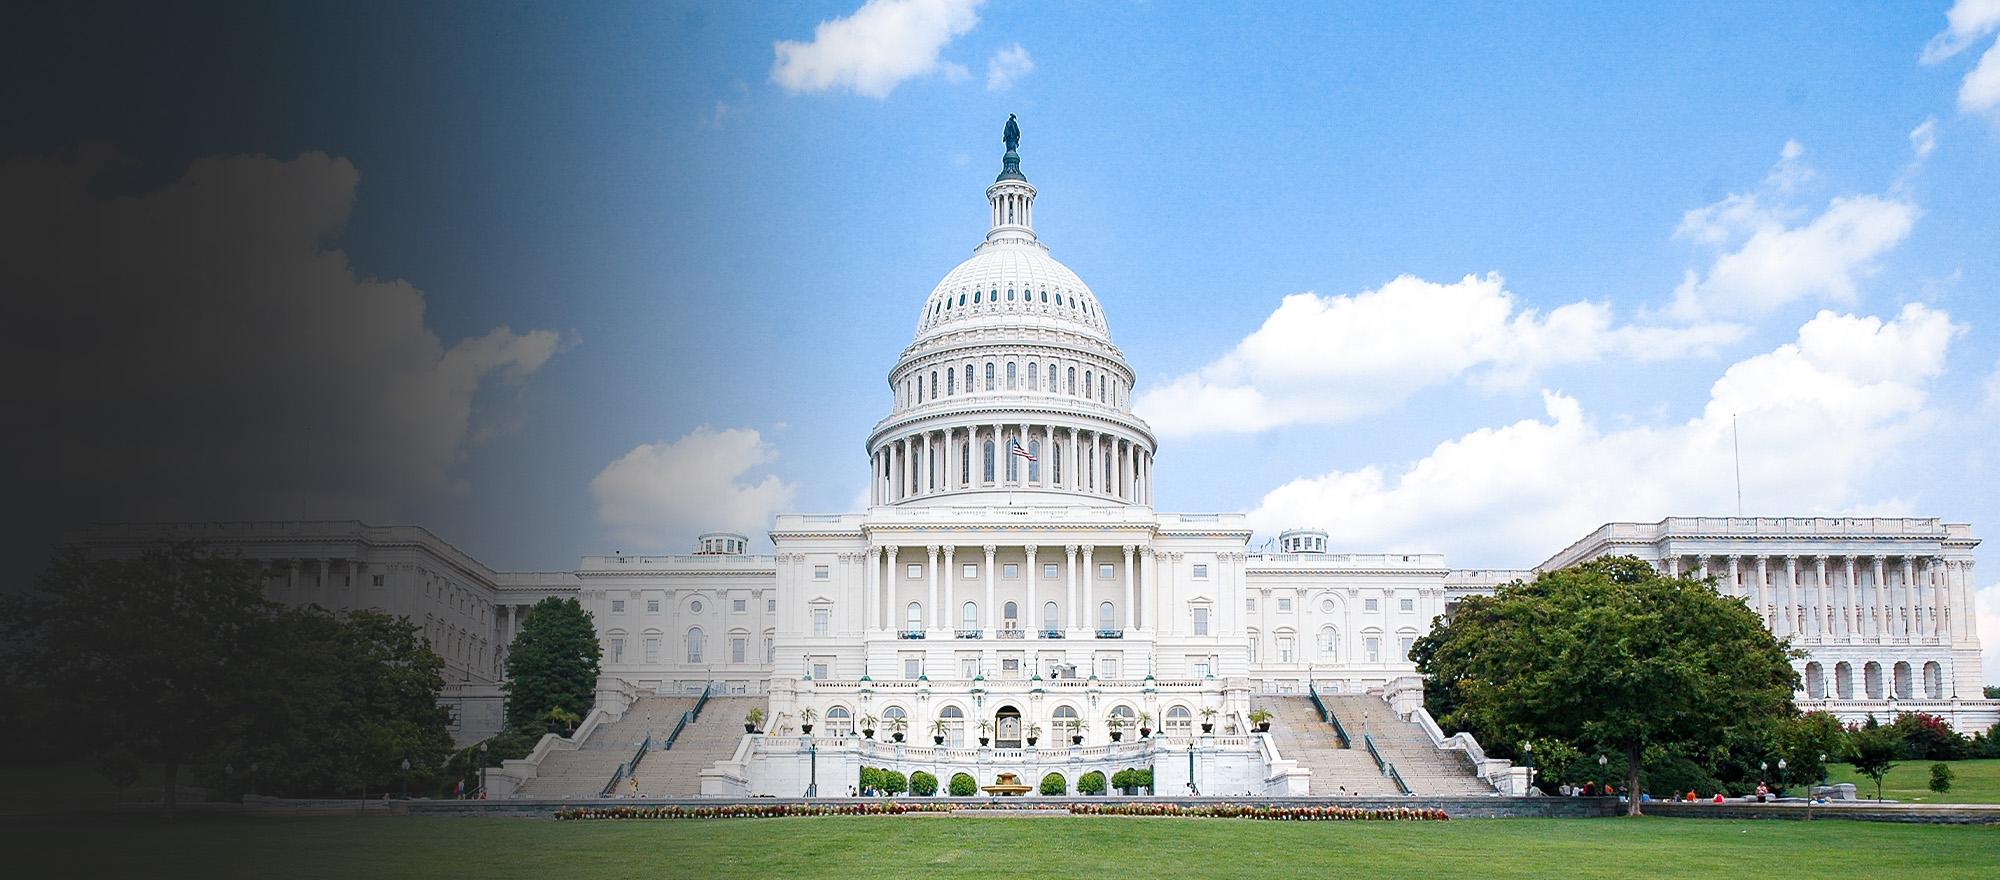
1412, 556, 1798, 816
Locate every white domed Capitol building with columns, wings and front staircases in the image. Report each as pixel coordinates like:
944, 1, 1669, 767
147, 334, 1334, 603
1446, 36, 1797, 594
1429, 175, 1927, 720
74, 122, 2000, 796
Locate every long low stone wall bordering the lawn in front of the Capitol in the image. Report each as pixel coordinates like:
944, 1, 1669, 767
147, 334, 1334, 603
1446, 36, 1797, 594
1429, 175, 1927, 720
408, 796, 1618, 818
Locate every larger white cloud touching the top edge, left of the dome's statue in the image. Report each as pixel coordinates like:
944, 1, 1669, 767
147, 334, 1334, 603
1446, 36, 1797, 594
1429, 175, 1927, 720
770, 0, 982, 98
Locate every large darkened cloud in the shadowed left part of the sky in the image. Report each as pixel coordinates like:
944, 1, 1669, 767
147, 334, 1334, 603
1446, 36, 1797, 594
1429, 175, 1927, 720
0, 146, 562, 518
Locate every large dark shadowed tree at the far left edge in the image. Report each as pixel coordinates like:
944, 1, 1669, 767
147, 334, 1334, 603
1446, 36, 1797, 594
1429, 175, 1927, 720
0, 544, 276, 816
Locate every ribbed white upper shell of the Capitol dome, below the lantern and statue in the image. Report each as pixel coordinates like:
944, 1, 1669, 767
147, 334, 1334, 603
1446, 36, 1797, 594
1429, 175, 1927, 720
916, 242, 1110, 342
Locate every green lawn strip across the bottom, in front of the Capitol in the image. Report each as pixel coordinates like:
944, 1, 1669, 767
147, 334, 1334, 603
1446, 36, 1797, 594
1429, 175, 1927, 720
0, 816, 2000, 880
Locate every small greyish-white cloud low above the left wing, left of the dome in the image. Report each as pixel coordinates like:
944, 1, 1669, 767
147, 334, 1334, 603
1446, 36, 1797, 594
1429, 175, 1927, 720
590, 426, 798, 550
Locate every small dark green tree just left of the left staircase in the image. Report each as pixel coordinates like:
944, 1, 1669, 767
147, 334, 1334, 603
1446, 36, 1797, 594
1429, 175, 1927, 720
504, 596, 602, 732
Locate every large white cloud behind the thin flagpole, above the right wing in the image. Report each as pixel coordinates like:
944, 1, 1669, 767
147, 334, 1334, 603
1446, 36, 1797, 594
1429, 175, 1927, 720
1250, 304, 1964, 566
